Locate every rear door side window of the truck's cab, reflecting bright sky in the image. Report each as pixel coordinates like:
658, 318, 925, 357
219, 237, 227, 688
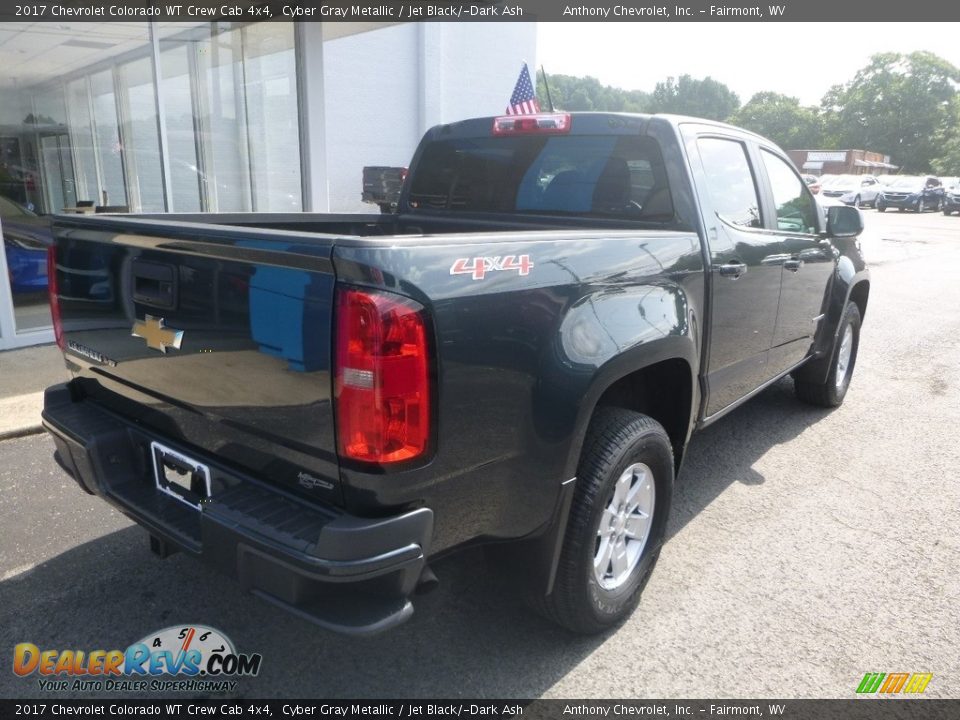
697, 137, 763, 228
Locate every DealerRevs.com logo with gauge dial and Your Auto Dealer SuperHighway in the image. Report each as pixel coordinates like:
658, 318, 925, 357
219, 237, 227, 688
13, 625, 263, 692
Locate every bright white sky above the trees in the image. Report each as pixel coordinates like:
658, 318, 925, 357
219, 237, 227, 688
537, 22, 960, 105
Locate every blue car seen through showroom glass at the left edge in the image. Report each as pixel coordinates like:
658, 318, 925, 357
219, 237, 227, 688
0, 197, 53, 293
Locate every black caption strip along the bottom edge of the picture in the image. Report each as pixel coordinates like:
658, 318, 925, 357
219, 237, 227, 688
0, 696, 960, 720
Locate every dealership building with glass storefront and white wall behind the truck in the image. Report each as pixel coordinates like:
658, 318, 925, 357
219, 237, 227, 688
0, 22, 536, 350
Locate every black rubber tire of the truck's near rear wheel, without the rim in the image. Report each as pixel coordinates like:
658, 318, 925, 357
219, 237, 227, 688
531, 407, 673, 634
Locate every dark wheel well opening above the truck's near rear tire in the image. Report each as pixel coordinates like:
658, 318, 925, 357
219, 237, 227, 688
597, 358, 693, 467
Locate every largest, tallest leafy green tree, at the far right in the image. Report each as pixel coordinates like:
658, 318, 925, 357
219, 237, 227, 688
821, 52, 960, 172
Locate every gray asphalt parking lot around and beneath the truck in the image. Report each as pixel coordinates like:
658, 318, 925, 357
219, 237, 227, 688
0, 210, 960, 698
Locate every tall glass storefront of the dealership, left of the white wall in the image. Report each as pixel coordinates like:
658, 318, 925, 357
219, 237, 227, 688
0, 22, 302, 347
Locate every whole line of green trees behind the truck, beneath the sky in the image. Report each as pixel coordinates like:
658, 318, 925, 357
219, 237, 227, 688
537, 52, 960, 175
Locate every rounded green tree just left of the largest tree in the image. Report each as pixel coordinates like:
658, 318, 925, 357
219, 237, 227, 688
730, 92, 822, 150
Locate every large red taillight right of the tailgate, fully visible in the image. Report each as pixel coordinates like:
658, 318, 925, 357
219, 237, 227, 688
334, 289, 430, 464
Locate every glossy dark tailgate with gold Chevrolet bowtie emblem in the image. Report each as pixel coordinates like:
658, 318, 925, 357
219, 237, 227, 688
54, 217, 341, 503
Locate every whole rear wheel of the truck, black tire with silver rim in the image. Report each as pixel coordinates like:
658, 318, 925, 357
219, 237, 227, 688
532, 407, 673, 634
